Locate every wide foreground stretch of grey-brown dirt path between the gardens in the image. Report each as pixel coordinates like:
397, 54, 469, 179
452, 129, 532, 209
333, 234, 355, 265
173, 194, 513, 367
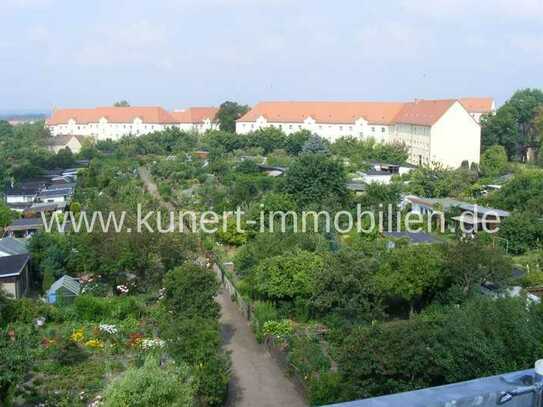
217, 290, 306, 407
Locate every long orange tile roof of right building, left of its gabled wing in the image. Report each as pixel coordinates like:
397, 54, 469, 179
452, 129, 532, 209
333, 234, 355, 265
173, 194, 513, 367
238, 102, 404, 124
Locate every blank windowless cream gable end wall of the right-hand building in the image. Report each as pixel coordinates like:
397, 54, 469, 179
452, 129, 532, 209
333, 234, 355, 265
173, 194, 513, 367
431, 102, 481, 168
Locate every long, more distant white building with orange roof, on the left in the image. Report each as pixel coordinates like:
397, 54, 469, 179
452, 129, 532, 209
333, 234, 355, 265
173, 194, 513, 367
46, 107, 217, 140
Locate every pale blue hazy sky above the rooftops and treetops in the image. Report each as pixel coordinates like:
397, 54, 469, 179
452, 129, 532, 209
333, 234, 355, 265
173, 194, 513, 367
0, 0, 543, 112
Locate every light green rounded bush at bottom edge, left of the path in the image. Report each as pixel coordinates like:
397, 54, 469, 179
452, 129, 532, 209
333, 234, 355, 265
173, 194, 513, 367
104, 357, 194, 407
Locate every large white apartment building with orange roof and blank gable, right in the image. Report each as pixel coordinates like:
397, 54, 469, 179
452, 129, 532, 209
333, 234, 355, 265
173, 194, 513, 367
236, 99, 481, 168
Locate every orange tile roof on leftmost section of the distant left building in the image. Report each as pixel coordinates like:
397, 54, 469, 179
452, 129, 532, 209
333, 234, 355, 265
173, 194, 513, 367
47, 106, 175, 125
